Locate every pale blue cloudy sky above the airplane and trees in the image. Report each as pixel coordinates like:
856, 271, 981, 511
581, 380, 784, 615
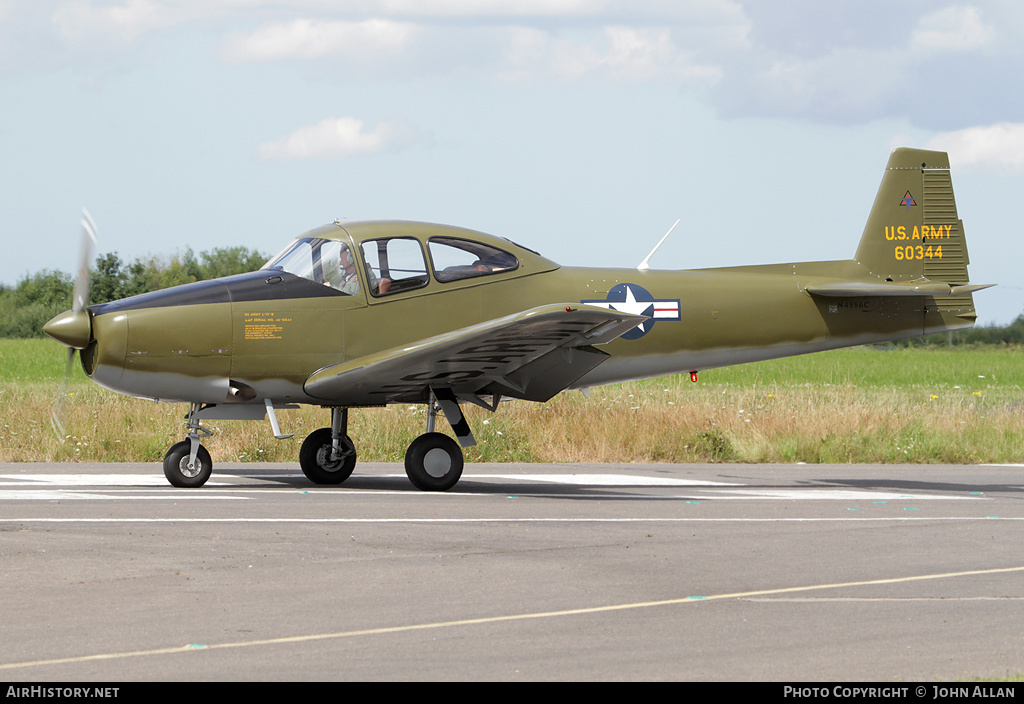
0, 0, 1024, 324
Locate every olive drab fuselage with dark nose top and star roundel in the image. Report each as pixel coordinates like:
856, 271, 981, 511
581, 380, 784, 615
64, 222, 971, 405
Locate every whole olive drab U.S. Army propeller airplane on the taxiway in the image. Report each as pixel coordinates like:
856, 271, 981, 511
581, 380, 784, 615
44, 148, 985, 490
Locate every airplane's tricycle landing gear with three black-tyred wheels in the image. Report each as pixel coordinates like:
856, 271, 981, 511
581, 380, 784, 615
164, 389, 479, 491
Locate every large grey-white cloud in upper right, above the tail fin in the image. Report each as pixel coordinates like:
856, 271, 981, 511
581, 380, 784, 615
707, 0, 1024, 130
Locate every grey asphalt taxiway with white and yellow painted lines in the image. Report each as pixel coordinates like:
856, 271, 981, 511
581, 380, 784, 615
0, 464, 1024, 681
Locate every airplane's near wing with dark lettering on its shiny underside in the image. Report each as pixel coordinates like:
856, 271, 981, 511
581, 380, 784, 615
305, 303, 648, 405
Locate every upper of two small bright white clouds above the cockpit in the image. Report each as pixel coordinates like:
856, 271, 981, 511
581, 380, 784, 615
223, 19, 417, 61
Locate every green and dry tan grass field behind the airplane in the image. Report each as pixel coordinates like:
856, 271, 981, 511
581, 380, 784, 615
0, 340, 1024, 464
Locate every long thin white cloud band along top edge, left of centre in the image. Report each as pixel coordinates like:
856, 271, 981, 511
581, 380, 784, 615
41, 0, 750, 83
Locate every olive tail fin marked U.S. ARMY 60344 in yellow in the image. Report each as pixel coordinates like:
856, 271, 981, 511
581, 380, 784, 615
856, 148, 968, 284
